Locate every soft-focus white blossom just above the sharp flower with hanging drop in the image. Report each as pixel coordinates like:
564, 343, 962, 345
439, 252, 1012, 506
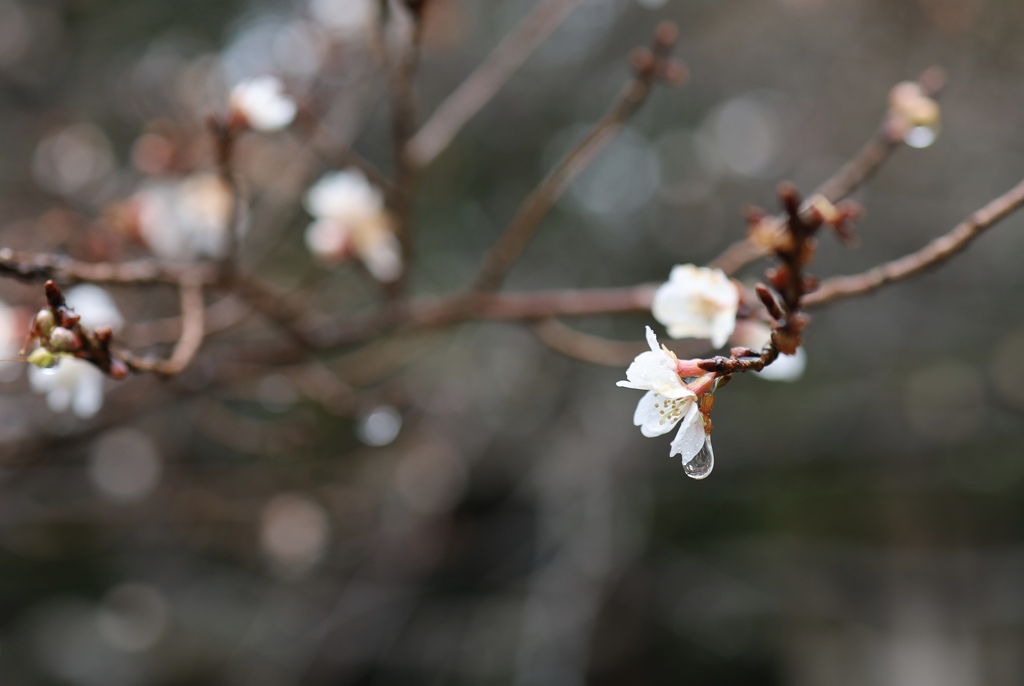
651, 264, 739, 348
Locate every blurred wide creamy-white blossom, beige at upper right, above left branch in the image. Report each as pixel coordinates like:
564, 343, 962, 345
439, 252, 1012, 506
131, 172, 232, 260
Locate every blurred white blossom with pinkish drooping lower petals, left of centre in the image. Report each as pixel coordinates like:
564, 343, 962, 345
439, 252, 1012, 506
304, 169, 402, 282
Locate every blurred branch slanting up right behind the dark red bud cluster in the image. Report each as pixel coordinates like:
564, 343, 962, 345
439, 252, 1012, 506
709, 67, 945, 274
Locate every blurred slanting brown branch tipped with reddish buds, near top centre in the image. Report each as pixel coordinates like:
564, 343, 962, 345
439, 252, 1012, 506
472, 24, 682, 291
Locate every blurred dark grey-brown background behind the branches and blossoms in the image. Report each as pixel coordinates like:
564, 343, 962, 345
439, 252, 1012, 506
0, 0, 1024, 686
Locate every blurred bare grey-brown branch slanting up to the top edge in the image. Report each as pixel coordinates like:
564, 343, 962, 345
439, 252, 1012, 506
407, 0, 582, 167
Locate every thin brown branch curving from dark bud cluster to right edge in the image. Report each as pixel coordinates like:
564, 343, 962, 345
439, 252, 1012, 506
804, 175, 1024, 307
